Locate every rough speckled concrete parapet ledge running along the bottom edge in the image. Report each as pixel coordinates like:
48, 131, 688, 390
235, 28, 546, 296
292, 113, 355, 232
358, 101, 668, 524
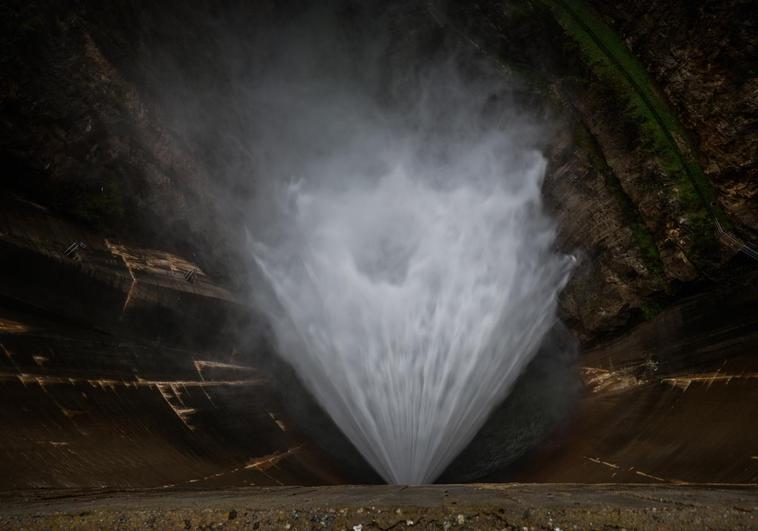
0, 484, 758, 531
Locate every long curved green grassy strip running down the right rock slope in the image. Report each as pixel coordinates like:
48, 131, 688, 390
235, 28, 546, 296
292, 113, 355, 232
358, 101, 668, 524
540, 0, 728, 260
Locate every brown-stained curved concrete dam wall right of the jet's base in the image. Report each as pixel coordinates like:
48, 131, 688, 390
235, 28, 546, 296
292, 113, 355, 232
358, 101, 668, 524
508, 274, 758, 484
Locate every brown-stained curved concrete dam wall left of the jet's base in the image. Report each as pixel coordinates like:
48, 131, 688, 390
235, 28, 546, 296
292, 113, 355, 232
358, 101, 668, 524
0, 296, 345, 490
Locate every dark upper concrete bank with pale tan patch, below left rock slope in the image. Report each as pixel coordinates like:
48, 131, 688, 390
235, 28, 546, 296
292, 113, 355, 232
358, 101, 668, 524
0, 197, 254, 349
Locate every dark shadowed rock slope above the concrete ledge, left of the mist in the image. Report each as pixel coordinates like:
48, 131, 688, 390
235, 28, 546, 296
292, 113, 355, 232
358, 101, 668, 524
0, 1, 248, 290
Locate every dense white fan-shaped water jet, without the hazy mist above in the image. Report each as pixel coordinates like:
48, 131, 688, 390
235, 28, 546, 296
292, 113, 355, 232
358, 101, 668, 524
255, 134, 567, 484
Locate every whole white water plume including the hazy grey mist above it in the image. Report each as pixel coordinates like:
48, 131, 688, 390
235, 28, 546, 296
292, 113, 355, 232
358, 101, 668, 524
236, 4, 570, 484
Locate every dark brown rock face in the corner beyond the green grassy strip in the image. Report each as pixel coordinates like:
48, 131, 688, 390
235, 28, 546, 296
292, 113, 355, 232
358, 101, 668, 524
593, 0, 758, 241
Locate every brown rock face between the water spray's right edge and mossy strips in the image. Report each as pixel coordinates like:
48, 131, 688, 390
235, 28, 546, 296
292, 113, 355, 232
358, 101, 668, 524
545, 124, 665, 341
